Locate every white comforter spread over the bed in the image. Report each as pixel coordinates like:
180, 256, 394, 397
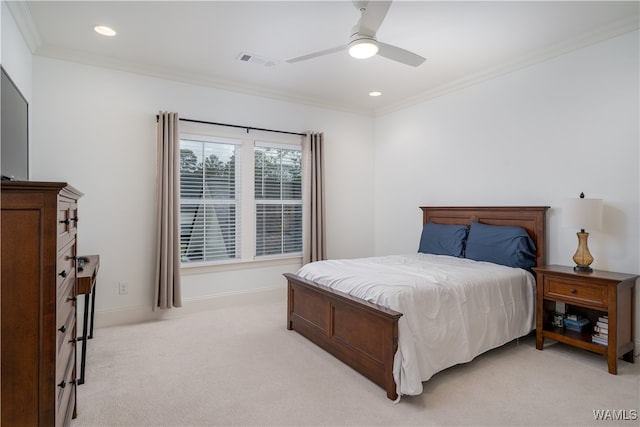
297, 253, 535, 396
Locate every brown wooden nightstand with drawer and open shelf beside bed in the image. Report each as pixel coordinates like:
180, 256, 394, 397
533, 265, 640, 375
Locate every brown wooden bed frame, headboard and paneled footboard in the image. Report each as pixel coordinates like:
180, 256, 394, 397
284, 206, 548, 400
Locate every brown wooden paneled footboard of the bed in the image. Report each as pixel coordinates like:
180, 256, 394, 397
284, 274, 402, 400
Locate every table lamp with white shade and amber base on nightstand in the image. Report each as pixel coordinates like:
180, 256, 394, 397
562, 193, 602, 272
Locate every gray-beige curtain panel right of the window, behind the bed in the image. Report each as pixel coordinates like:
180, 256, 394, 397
302, 132, 327, 264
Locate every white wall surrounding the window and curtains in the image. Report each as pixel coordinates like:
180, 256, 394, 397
31, 57, 373, 324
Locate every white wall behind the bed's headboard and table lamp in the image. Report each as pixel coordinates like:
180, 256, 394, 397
374, 31, 640, 341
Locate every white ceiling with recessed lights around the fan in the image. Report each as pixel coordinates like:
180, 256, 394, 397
8, 0, 640, 114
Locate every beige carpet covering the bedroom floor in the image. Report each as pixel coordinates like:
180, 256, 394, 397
72, 301, 640, 427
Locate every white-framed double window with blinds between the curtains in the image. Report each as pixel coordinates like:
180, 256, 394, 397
180, 130, 302, 265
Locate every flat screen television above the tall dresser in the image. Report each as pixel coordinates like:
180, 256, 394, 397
0, 67, 29, 181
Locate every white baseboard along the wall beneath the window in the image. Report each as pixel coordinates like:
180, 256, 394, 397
94, 285, 287, 328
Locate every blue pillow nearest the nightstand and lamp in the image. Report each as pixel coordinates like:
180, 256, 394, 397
465, 222, 536, 270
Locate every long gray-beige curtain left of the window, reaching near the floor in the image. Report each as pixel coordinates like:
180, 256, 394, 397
153, 112, 182, 310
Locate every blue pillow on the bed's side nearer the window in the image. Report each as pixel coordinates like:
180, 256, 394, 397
418, 222, 469, 257
